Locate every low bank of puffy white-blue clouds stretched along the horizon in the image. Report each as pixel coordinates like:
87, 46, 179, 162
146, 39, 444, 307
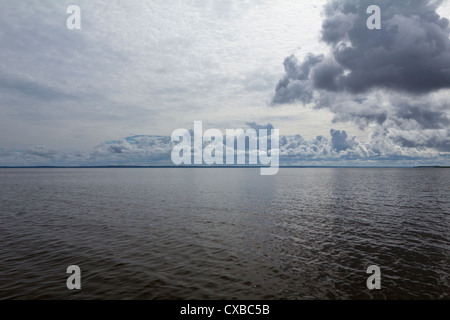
0, 122, 450, 166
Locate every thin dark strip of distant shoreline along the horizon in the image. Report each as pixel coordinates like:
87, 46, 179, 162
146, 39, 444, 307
0, 165, 450, 169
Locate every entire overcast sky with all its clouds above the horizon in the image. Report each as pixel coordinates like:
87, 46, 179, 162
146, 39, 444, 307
0, 0, 450, 166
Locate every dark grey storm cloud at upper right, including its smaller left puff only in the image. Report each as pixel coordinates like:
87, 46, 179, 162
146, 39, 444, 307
273, 0, 450, 103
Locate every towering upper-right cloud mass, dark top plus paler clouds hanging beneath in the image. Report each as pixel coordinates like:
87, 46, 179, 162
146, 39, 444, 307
272, 0, 450, 156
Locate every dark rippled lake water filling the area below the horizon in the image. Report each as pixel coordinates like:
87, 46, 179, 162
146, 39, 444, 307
0, 168, 450, 299
